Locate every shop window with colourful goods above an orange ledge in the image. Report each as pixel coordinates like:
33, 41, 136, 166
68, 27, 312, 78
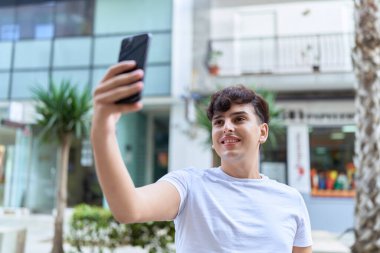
310, 126, 355, 197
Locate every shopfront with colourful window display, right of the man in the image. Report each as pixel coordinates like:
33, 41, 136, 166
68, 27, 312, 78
261, 100, 356, 233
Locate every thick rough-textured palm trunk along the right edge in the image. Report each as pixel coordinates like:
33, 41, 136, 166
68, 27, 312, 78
352, 0, 380, 253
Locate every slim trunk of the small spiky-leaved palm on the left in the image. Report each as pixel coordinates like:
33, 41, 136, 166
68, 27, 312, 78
52, 134, 71, 253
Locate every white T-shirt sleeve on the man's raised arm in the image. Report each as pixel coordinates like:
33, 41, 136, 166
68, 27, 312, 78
158, 168, 193, 216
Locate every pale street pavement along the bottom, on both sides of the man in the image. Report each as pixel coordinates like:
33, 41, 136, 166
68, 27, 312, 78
0, 209, 354, 253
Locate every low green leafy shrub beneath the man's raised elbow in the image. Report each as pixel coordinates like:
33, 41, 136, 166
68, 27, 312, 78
67, 205, 174, 253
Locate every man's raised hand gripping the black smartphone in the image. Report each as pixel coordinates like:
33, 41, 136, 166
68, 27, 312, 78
92, 61, 144, 133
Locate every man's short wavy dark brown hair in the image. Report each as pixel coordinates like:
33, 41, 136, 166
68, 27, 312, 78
207, 85, 269, 123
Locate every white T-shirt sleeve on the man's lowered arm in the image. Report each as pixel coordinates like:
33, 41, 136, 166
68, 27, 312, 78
293, 193, 313, 247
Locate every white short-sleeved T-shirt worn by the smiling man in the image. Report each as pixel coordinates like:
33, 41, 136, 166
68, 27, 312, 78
160, 168, 312, 253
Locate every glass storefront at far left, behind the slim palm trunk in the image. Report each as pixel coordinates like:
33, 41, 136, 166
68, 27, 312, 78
0, 102, 102, 213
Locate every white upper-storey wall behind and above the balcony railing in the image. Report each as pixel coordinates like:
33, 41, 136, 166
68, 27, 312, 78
211, 0, 354, 76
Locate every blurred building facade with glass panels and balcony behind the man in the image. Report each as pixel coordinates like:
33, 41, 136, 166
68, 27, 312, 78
0, 0, 355, 232
